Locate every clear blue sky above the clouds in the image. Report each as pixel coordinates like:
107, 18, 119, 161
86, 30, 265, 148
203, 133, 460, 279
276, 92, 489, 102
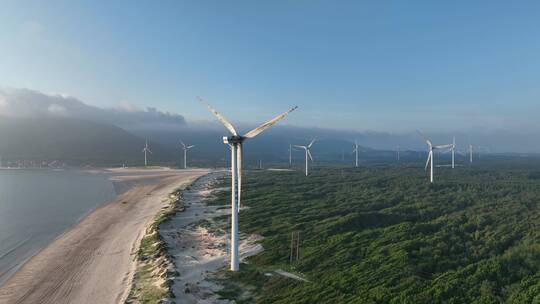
0, 1, 540, 132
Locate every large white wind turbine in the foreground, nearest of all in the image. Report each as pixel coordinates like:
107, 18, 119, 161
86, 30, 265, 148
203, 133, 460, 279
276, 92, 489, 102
199, 98, 298, 271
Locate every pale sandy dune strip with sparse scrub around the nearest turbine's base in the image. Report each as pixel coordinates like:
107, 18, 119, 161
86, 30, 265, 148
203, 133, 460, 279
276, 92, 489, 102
160, 176, 263, 304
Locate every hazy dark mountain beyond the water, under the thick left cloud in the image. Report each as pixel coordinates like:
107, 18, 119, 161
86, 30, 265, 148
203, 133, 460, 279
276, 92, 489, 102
0, 117, 174, 165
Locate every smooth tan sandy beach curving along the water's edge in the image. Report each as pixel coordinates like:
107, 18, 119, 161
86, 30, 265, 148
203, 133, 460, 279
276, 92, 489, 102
0, 170, 208, 304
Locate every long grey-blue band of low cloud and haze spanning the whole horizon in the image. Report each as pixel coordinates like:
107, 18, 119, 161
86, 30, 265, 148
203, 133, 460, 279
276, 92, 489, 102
0, 87, 540, 154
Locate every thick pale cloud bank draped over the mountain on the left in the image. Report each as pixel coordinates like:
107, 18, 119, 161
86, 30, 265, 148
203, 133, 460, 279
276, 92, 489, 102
0, 88, 186, 130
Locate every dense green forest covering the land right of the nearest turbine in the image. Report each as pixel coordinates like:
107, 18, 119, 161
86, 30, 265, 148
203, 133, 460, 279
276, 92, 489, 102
216, 162, 540, 303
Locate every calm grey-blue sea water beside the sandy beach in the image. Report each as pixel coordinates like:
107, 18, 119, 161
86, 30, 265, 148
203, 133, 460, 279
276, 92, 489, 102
0, 169, 116, 285
